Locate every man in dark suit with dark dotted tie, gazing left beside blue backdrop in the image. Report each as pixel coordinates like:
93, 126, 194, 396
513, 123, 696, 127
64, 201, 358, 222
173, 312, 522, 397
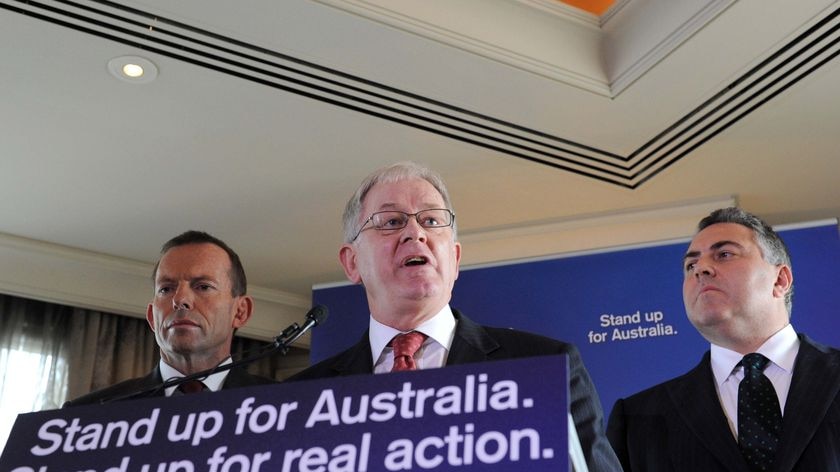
607, 208, 840, 472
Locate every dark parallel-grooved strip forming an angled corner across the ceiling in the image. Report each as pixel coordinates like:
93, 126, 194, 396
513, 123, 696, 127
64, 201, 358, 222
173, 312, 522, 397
0, 0, 840, 189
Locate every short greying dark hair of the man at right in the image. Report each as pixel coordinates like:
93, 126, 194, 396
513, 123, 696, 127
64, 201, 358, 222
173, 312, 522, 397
697, 207, 793, 315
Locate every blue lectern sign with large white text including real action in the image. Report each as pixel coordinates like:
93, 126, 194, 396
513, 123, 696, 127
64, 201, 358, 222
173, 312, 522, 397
0, 356, 569, 472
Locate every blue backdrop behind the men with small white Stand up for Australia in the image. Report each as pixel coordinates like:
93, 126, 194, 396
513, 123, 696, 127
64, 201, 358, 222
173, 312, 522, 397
312, 221, 840, 420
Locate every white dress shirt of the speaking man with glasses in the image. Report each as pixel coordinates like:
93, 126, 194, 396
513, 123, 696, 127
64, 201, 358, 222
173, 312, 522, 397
369, 305, 457, 374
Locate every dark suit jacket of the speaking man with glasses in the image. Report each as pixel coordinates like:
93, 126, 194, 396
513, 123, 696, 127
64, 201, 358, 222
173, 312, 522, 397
289, 310, 621, 472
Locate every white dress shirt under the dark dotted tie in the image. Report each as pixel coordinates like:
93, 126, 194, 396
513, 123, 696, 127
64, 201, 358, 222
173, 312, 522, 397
711, 324, 799, 439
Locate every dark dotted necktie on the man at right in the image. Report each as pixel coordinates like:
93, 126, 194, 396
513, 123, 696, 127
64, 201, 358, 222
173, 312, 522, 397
738, 353, 782, 471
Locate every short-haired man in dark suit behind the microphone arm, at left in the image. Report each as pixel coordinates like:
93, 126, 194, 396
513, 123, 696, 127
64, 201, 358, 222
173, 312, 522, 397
65, 231, 273, 406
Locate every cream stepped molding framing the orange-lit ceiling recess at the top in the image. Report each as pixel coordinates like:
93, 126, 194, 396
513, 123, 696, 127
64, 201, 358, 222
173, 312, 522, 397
315, 0, 735, 98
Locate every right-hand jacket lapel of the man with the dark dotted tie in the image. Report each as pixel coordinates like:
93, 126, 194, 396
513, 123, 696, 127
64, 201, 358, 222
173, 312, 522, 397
773, 334, 840, 471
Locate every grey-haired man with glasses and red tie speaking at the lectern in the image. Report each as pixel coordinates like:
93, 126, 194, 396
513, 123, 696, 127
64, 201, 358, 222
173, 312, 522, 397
291, 162, 621, 472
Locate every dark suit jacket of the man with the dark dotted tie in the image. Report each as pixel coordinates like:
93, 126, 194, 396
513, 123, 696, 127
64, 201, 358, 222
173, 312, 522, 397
607, 334, 840, 472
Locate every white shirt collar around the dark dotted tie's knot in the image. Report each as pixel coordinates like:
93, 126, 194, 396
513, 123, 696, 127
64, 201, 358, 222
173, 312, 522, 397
711, 323, 799, 386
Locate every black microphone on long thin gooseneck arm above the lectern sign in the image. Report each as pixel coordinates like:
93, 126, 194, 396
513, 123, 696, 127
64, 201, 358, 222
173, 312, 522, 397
100, 305, 329, 403
